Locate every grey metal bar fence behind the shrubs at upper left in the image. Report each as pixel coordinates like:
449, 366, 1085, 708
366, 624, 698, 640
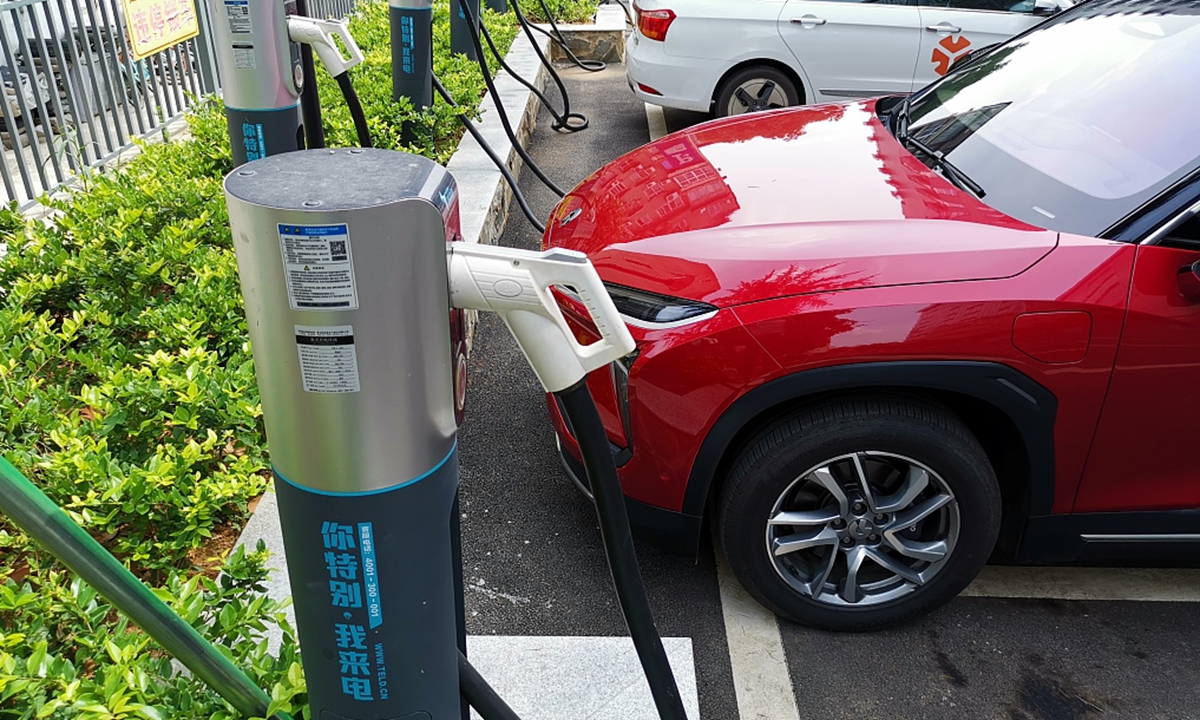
0, 0, 355, 208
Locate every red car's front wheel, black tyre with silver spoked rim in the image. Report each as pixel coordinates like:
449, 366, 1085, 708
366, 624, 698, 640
714, 396, 1001, 631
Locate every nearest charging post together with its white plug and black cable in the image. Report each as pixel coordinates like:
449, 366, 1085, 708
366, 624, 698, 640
224, 146, 657, 720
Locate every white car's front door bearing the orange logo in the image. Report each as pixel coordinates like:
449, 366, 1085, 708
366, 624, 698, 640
912, 0, 1045, 90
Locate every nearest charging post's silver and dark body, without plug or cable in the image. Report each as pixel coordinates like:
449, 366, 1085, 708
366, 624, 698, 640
226, 149, 463, 720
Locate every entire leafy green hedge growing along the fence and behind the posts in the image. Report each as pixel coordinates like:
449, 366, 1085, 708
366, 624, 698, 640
0, 0, 515, 720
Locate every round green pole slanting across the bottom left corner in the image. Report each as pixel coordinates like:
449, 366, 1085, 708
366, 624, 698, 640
0, 457, 292, 720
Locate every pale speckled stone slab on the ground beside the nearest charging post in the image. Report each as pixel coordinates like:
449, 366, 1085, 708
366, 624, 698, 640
467, 635, 700, 720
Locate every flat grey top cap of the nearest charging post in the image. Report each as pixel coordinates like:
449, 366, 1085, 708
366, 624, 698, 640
224, 148, 456, 211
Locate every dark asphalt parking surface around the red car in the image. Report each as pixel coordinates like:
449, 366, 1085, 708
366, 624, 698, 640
460, 61, 1200, 720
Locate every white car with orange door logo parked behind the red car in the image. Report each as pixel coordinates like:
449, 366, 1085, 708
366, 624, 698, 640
625, 0, 1074, 116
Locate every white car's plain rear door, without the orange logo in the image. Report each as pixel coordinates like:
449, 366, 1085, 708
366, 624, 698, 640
779, 0, 922, 103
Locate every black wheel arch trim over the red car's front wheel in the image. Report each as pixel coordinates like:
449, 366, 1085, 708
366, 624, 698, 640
682, 361, 1058, 516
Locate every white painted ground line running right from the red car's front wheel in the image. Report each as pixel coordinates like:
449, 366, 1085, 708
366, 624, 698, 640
962, 565, 1200, 602
